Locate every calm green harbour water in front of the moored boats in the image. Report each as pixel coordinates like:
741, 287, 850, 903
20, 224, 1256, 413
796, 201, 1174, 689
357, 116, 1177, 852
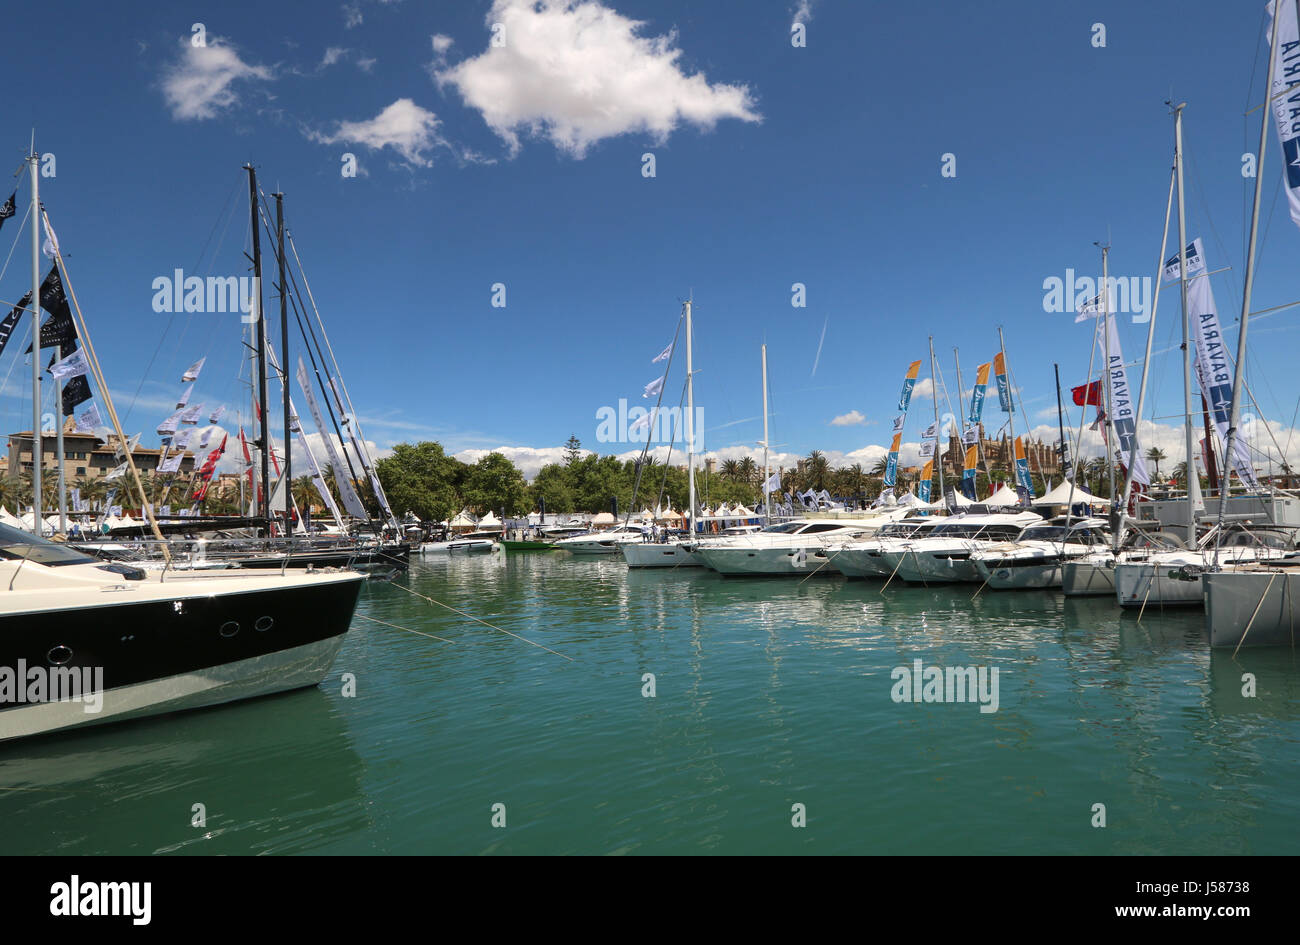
0, 552, 1300, 854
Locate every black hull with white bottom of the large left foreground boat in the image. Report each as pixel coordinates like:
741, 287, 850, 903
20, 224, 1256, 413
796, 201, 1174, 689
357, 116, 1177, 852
0, 575, 364, 741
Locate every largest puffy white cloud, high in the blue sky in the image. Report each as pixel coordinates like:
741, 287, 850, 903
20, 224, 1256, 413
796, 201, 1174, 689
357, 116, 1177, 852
433, 0, 761, 157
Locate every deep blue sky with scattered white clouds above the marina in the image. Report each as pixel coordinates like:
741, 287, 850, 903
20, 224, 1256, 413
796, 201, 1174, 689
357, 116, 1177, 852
0, 0, 1300, 480
